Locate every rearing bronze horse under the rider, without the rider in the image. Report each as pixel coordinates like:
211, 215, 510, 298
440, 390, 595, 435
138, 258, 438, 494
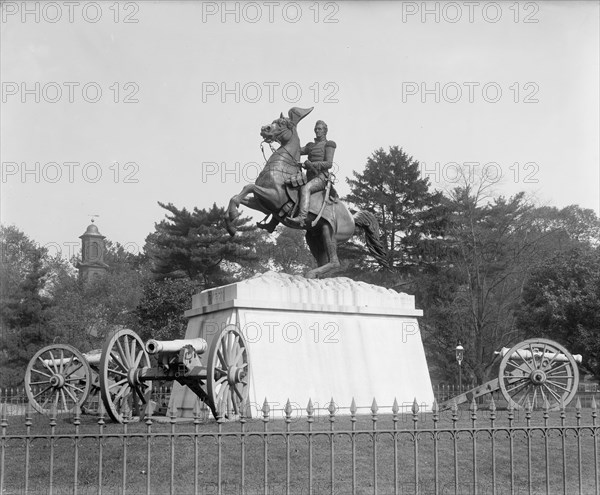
225, 107, 388, 278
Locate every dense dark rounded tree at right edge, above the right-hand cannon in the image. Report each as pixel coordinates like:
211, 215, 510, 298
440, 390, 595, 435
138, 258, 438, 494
517, 250, 600, 379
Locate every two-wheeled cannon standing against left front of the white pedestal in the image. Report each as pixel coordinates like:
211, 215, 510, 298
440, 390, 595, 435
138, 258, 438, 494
99, 325, 250, 422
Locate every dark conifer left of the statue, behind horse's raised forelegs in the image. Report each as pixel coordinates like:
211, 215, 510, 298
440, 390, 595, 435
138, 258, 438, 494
145, 203, 266, 288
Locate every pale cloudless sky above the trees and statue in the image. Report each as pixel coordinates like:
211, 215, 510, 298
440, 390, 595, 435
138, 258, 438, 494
0, 1, 600, 258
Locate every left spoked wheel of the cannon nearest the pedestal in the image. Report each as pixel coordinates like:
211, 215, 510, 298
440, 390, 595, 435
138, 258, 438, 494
99, 329, 152, 423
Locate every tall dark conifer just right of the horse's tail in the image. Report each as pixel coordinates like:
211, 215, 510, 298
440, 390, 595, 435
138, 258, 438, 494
344, 146, 445, 283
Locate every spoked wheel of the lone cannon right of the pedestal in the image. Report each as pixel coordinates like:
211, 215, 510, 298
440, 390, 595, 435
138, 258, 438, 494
498, 339, 579, 411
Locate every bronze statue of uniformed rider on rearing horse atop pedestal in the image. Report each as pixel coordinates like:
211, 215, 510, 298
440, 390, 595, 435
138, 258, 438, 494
225, 107, 388, 278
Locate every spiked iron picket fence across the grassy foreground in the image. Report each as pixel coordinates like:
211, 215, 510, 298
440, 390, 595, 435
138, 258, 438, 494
0, 398, 600, 495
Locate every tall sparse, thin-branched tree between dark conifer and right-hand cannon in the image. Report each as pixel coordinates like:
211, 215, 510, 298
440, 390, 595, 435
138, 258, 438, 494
415, 174, 549, 383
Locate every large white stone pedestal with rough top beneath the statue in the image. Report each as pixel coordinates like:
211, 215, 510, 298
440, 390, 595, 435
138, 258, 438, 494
169, 272, 433, 417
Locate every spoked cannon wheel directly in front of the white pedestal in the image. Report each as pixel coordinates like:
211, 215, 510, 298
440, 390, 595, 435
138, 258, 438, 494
206, 325, 250, 418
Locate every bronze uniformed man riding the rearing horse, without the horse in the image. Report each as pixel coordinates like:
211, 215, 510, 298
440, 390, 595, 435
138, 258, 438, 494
289, 120, 336, 227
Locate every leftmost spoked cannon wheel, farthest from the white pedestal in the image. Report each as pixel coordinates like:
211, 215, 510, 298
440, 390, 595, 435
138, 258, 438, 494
25, 344, 92, 414
